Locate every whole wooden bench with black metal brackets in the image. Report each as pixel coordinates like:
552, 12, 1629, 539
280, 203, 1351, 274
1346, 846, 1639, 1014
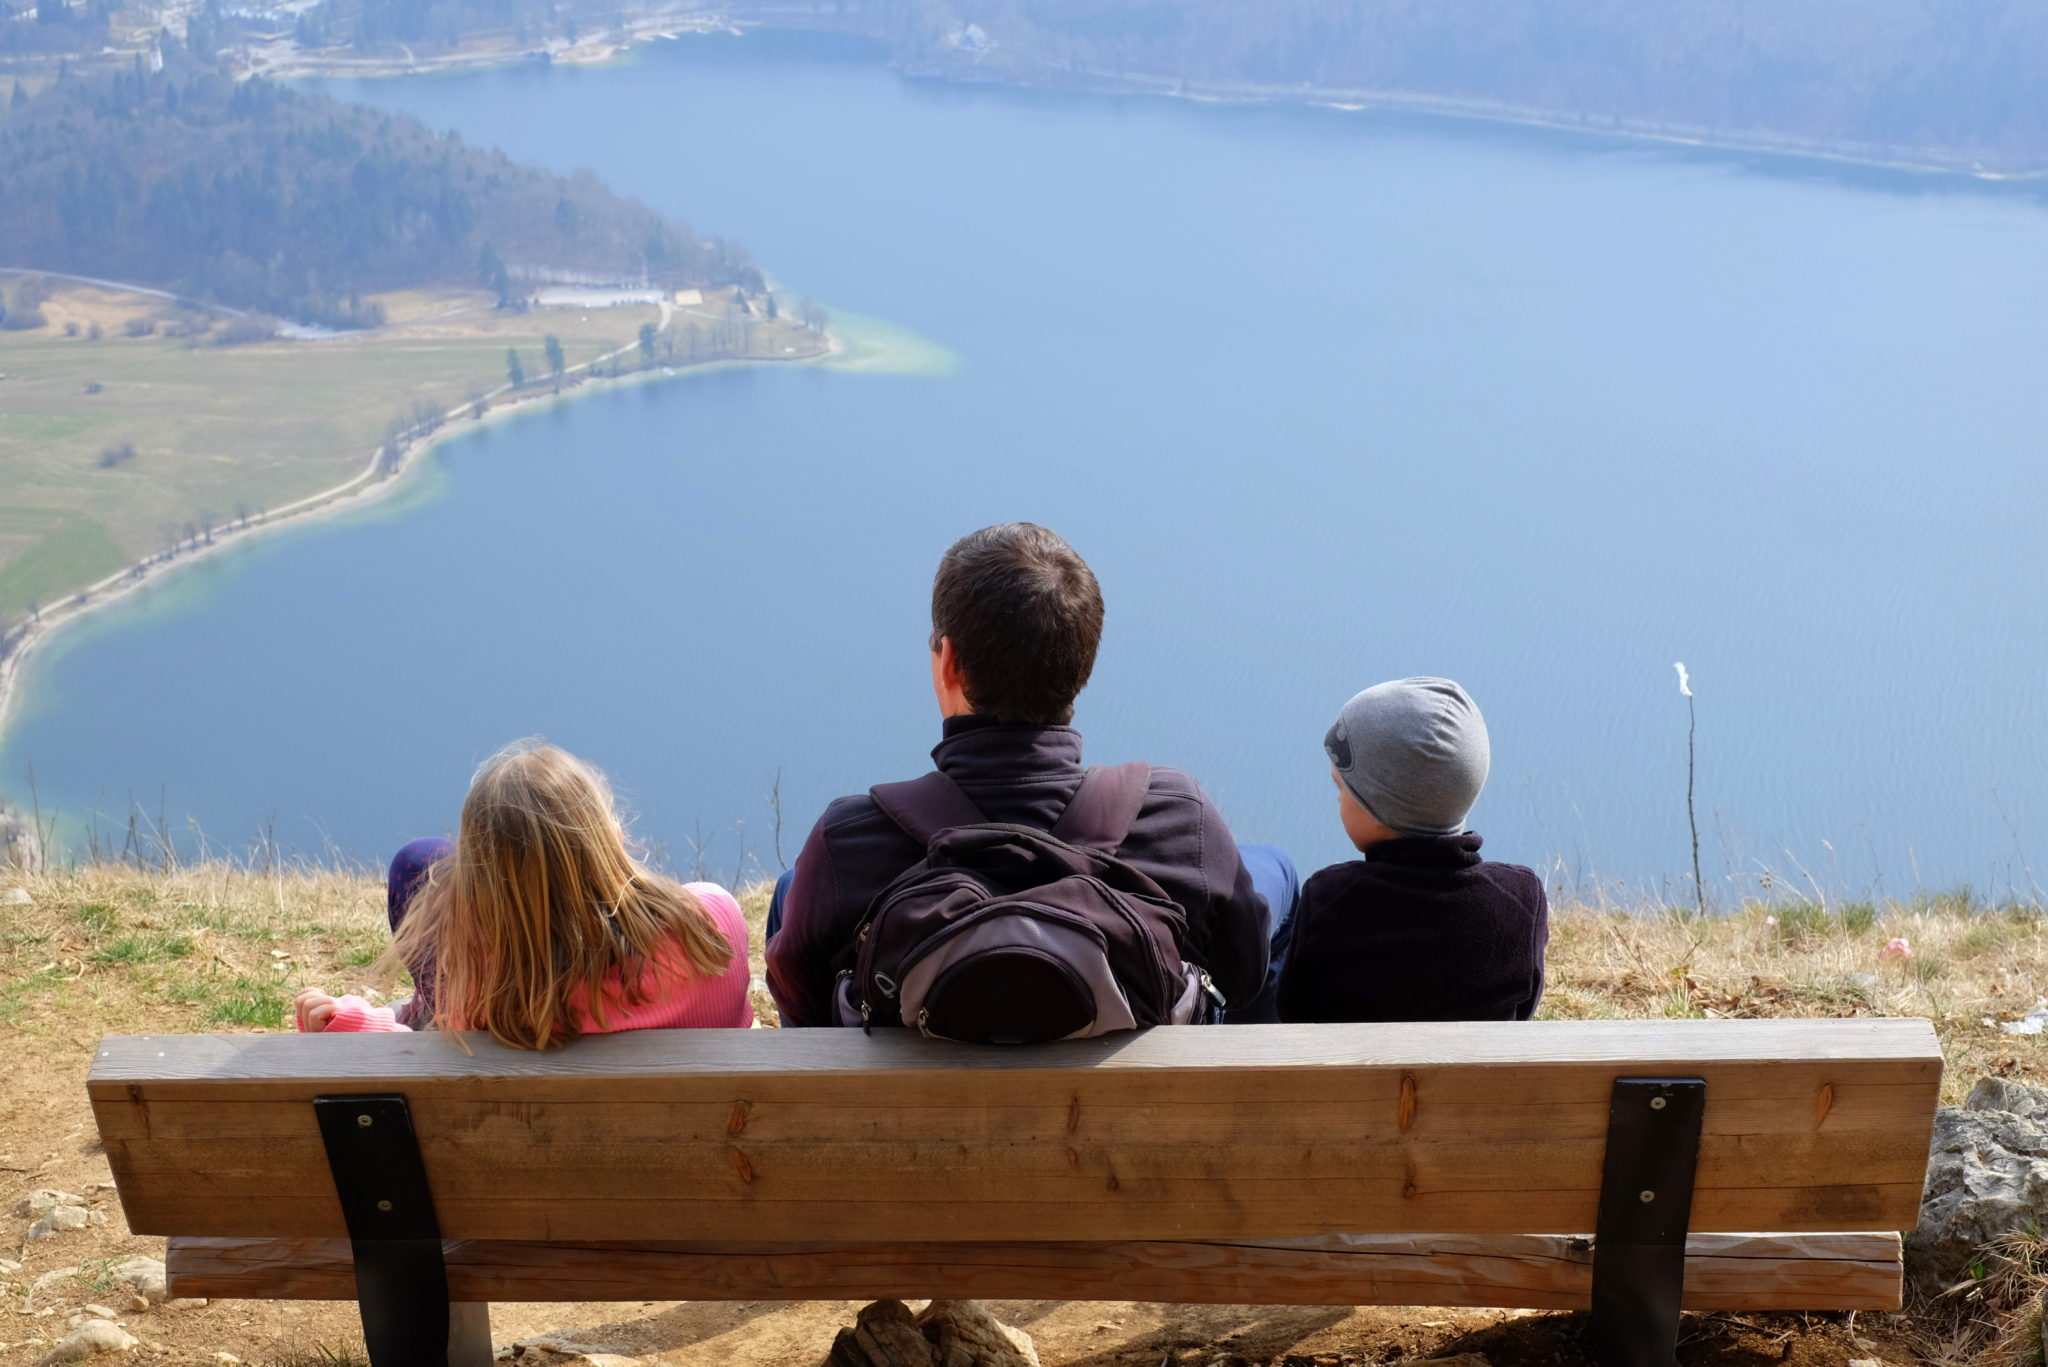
88, 1021, 1942, 1367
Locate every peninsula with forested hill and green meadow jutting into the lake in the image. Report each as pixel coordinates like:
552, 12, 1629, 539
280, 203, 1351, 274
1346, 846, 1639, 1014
0, 59, 829, 754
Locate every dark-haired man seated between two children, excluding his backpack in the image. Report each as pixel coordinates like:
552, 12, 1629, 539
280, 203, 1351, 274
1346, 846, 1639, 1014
768, 523, 1296, 1025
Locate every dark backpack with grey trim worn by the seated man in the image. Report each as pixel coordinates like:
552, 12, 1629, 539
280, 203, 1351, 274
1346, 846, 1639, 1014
838, 764, 1223, 1043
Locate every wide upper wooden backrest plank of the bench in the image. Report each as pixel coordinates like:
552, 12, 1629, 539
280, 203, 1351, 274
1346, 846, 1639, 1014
88, 1021, 1942, 1242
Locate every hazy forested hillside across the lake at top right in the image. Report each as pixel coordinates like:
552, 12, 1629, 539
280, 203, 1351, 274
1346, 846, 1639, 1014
727, 0, 2048, 170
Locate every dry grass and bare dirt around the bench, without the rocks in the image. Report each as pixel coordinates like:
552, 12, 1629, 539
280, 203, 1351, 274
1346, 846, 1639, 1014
0, 865, 2048, 1367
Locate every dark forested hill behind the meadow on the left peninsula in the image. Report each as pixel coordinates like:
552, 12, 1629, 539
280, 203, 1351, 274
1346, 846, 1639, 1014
0, 64, 760, 326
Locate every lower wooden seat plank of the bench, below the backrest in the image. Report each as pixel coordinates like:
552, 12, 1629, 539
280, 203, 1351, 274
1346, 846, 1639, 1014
166, 1234, 1901, 1310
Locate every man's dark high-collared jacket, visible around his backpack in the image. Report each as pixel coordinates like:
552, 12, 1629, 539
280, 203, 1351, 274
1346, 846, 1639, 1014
768, 717, 1266, 1025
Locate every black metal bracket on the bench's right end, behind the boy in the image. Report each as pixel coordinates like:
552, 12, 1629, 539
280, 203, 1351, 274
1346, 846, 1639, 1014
1585, 1078, 1706, 1367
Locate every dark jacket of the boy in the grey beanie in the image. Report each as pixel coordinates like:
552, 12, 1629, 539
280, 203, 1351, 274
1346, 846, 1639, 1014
1280, 832, 1550, 1021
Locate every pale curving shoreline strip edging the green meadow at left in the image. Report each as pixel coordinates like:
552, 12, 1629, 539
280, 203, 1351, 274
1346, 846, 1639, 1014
0, 317, 844, 770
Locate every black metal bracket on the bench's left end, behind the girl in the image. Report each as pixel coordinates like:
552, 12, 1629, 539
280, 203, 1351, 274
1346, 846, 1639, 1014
313, 1094, 492, 1367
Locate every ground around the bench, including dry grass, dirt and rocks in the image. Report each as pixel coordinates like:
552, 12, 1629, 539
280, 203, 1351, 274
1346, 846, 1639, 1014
0, 865, 2048, 1367
